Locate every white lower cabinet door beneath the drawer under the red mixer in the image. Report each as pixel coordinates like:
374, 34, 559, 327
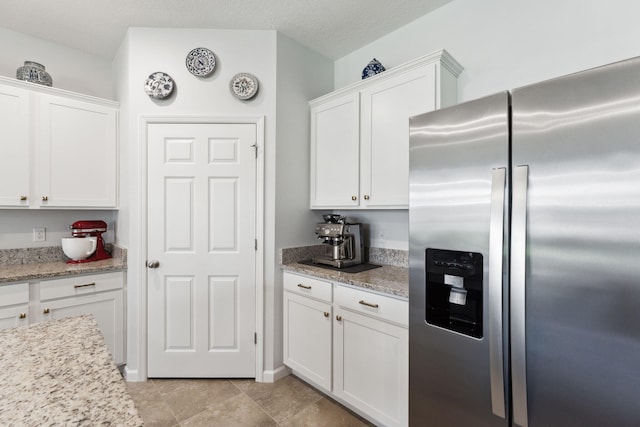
40, 290, 124, 363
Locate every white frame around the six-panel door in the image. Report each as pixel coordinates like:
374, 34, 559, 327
132, 116, 264, 382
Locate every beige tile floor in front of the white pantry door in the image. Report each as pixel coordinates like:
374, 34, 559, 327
127, 375, 373, 427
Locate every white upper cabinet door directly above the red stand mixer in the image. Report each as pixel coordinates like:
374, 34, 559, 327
36, 95, 117, 208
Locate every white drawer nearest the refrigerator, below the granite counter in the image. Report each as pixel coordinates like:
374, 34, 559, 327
334, 284, 409, 326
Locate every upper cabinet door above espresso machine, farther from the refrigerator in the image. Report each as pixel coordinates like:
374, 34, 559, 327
310, 93, 360, 209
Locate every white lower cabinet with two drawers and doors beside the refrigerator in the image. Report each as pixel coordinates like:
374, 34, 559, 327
283, 272, 409, 426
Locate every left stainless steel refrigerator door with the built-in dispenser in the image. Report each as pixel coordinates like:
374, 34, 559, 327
409, 92, 509, 427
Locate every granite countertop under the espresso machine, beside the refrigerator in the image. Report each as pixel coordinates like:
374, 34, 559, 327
282, 262, 409, 299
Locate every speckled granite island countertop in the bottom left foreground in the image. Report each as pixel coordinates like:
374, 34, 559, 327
0, 315, 143, 426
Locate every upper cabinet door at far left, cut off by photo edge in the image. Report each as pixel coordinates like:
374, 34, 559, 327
0, 86, 30, 207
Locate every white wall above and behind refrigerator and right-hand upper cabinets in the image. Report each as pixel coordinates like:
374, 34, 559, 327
334, 0, 640, 250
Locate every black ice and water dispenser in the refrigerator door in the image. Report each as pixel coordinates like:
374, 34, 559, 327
426, 249, 482, 338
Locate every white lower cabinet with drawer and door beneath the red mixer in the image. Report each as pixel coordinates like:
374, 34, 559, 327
34, 272, 124, 363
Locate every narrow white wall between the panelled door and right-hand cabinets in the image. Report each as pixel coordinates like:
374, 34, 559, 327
272, 34, 333, 378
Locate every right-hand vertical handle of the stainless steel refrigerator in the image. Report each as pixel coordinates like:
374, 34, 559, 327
510, 166, 529, 427
